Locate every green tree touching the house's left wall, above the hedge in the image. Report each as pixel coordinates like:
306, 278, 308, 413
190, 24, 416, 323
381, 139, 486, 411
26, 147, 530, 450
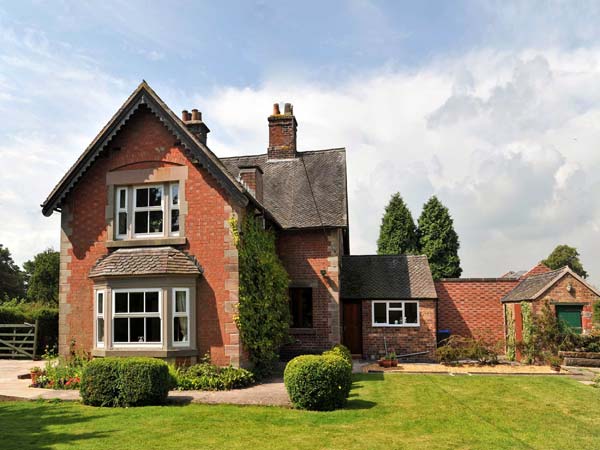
23, 249, 60, 305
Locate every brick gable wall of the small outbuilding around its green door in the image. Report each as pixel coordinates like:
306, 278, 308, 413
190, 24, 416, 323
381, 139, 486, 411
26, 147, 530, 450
533, 274, 600, 333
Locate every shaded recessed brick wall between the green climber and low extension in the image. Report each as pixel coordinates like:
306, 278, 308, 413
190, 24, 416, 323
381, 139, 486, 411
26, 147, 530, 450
277, 230, 340, 356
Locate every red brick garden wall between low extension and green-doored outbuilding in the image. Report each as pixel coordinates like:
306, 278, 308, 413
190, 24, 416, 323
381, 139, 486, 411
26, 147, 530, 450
435, 278, 519, 342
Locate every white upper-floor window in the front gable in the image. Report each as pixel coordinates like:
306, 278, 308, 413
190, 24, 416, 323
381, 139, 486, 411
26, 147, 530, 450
114, 182, 180, 240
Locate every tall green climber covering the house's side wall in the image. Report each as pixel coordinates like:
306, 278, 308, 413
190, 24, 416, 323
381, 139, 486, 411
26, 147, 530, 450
232, 217, 290, 378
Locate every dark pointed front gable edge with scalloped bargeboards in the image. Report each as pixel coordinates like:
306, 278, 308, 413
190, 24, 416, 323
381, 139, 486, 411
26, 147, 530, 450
41, 81, 248, 216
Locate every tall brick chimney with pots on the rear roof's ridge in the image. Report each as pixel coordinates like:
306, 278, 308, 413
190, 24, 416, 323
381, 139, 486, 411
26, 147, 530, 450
267, 103, 298, 159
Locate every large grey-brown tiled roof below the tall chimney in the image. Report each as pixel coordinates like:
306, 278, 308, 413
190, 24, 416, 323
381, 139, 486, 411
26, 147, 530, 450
221, 148, 348, 229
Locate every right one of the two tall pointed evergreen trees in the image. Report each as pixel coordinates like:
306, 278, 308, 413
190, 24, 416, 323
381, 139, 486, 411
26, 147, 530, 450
419, 195, 462, 280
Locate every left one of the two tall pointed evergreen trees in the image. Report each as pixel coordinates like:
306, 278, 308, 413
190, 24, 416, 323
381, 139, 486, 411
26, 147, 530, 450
377, 193, 419, 255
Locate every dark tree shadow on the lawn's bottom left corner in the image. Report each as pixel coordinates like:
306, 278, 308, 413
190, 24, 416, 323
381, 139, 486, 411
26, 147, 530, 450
0, 401, 110, 450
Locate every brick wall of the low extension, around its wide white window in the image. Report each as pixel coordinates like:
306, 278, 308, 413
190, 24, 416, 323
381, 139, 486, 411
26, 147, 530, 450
362, 300, 436, 361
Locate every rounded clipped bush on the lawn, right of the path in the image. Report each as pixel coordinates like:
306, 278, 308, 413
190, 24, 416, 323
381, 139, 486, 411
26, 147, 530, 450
283, 354, 352, 411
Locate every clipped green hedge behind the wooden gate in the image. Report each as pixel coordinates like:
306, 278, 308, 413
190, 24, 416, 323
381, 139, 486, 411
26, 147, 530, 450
0, 301, 58, 355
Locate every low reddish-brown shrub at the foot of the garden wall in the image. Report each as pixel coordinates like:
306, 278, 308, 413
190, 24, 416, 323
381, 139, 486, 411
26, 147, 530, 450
435, 336, 498, 365
